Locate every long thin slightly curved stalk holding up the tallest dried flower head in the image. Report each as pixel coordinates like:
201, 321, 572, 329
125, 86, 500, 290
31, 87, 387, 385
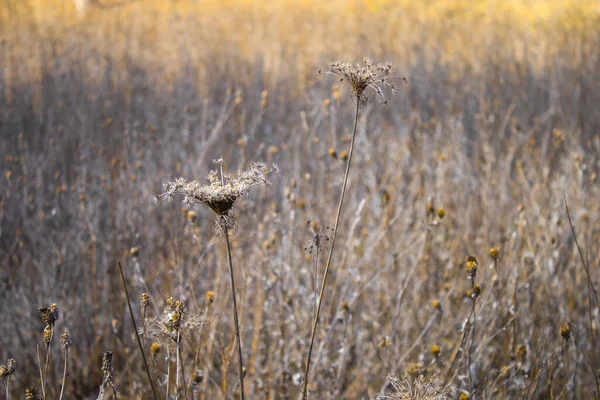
302, 95, 360, 400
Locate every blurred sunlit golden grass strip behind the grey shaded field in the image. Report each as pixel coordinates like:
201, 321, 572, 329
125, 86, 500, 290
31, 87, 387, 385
0, 0, 600, 93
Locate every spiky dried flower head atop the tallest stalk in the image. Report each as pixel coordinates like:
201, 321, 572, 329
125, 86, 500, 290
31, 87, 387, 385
319, 58, 395, 102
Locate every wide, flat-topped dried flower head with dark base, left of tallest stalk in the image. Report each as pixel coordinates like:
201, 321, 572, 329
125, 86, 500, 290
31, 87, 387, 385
158, 159, 277, 233
